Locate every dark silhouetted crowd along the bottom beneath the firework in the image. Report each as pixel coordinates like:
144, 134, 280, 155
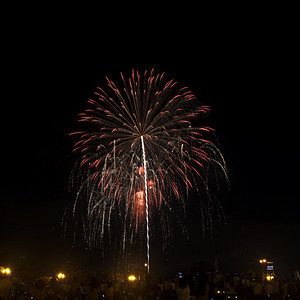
0, 271, 300, 300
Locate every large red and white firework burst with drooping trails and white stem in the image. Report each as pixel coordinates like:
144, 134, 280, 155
67, 70, 227, 272
